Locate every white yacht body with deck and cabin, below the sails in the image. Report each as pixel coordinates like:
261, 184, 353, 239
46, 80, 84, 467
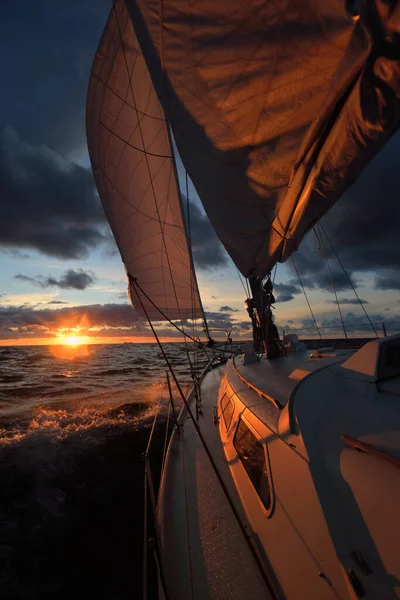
158, 338, 400, 600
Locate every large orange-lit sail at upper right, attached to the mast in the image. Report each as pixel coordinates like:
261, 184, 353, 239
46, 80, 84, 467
127, 0, 399, 277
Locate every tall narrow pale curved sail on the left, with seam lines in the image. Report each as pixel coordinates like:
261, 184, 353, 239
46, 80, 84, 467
87, 0, 202, 320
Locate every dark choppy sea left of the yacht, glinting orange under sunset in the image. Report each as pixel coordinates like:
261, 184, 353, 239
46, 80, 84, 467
0, 344, 195, 600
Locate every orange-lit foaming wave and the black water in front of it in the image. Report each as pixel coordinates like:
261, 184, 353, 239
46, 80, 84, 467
0, 399, 164, 600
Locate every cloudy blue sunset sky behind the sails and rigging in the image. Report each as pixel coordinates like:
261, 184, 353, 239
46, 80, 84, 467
0, 0, 400, 345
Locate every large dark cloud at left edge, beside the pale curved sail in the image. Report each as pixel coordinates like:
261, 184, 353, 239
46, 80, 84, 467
0, 128, 107, 259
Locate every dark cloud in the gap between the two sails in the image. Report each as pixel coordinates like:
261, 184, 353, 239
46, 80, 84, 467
183, 198, 228, 270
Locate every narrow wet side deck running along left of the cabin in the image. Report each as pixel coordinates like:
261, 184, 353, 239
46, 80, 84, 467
158, 367, 272, 600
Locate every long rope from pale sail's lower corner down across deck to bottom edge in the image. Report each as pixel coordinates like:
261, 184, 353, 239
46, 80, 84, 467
133, 281, 279, 600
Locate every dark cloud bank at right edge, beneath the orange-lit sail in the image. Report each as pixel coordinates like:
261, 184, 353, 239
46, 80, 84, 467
287, 134, 400, 290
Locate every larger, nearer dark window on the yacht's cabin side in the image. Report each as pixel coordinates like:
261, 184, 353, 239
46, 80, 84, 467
233, 419, 271, 510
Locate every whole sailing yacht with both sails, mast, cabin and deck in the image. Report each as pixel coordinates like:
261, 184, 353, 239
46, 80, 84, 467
87, 0, 400, 600
